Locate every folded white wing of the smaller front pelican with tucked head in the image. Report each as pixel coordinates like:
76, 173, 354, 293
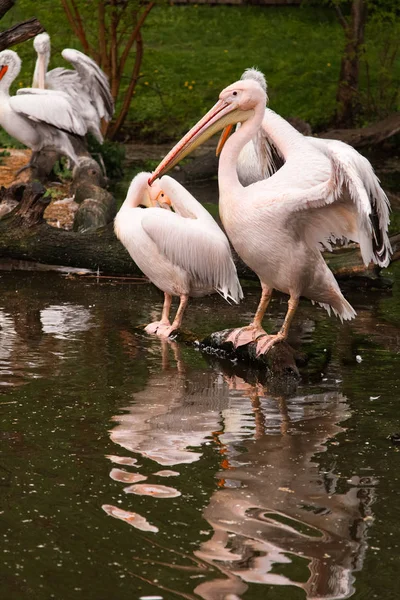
142, 209, 243, 302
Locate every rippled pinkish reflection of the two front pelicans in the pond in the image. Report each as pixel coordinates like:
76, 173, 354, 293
103, 341, 374, 600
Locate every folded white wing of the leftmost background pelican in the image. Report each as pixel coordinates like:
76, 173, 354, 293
10, 88, 87, 136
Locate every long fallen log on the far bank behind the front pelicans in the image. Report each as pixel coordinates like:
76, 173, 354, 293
0, 182, 400, 286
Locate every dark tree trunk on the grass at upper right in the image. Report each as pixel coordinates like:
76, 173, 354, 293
335, 0, 367, 127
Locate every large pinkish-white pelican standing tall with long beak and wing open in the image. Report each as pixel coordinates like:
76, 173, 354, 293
150, 79, 391, 354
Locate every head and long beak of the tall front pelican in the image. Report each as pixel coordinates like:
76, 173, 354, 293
149, 79, 267, 185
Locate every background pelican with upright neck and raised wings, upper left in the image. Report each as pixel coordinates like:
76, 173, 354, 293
32, 33, 114, 143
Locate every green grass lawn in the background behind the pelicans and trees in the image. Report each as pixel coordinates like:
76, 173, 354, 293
2, 0, 400, 142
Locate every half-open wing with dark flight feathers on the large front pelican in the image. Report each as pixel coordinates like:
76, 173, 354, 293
262, 138, 391, 267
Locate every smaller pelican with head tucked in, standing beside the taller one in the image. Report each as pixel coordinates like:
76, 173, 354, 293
114, 173, 243, 337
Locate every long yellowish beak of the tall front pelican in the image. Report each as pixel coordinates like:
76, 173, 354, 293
149, 100, 254, 185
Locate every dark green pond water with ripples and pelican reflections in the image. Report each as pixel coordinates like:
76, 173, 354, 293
0, 269, 400, 600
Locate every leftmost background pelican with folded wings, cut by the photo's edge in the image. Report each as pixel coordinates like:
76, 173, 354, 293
0, 50, 87, 166
